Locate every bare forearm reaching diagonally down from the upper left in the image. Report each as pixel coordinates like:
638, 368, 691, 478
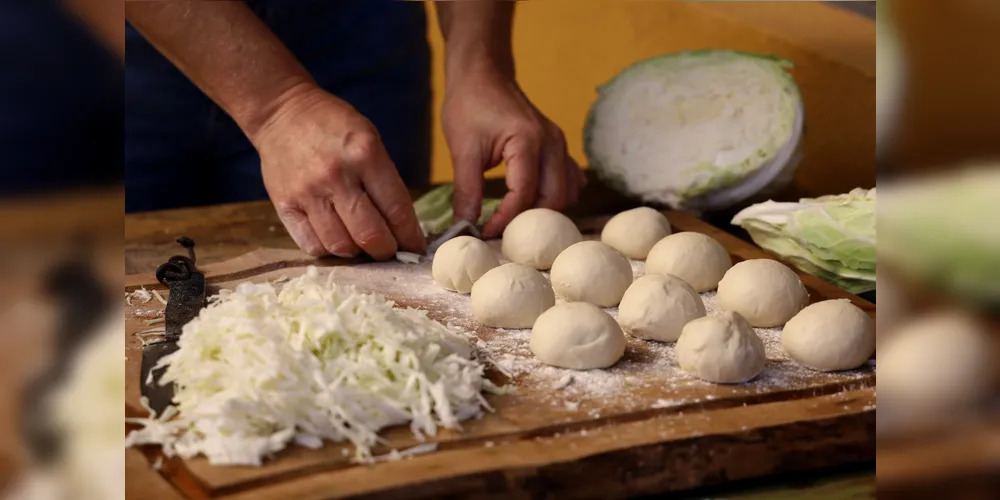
125, 1, 315, 141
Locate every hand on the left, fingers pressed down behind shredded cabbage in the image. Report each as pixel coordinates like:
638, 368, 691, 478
251, 86, 427, 260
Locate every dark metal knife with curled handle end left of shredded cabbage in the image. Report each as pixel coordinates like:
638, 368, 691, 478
140, 237, 205, 415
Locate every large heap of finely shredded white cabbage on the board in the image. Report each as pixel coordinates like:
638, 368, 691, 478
126, 266, 497, 465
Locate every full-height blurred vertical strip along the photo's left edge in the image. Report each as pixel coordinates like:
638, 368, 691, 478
0, 0, 125, 500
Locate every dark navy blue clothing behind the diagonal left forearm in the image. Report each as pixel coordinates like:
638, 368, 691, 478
125, 0, 431, 212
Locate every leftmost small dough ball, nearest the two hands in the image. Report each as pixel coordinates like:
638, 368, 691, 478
431, 236, 500, 293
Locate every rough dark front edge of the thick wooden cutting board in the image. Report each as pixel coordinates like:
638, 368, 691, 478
214, 389, 875, 500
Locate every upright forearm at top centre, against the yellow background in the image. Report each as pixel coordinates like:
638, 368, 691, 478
434, 0, 515, 82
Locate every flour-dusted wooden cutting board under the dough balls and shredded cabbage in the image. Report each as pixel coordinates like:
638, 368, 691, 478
126, 211, 875, 499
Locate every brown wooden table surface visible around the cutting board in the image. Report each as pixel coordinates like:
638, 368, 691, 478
125, 175, 875, 499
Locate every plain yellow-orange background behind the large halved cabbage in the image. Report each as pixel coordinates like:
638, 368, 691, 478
426, 0, 875, 201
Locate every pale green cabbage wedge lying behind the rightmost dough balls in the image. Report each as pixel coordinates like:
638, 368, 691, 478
733, 189, 876, 293
